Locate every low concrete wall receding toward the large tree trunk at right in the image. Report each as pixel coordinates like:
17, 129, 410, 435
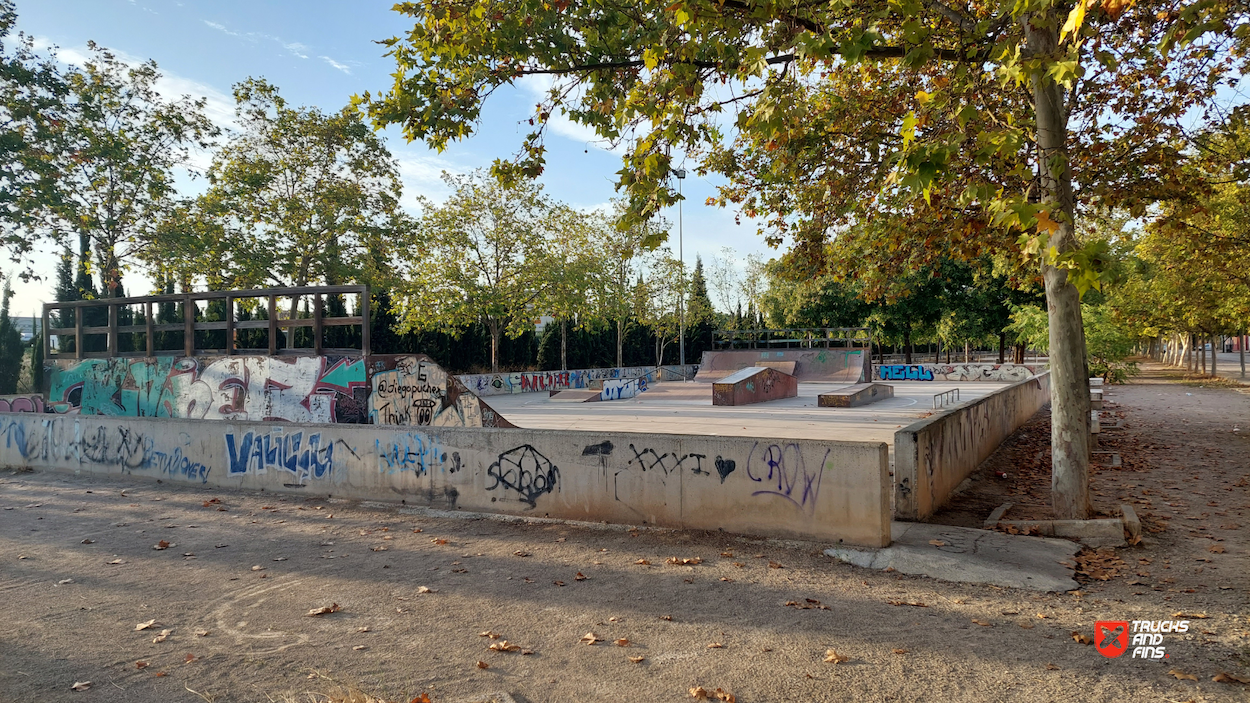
894, 372, 1050, 520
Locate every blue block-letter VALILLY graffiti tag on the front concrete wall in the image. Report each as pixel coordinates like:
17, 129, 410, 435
225, 428, 335, 484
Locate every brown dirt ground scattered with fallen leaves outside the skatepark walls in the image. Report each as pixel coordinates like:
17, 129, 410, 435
0, 362, 1250, 703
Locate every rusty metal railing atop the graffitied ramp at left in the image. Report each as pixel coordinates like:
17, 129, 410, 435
44, 285, 369, 360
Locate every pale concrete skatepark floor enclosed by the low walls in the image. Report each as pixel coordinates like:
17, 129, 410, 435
486, 382, 1008, 447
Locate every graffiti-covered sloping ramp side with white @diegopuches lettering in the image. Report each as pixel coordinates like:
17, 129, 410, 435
369, 357, 510, 427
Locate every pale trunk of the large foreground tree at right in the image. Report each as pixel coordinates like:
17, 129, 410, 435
1024, 11, 1091, 519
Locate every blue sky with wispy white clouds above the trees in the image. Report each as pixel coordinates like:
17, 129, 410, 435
13, 0, 773, 315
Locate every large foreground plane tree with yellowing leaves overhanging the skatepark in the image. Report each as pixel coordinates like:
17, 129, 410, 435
359, 0, 1246, 518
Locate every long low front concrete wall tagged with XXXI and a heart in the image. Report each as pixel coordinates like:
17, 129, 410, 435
0, 413, 890, 547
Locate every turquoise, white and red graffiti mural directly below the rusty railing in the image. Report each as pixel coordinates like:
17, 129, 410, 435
49, 357, 369, 423
